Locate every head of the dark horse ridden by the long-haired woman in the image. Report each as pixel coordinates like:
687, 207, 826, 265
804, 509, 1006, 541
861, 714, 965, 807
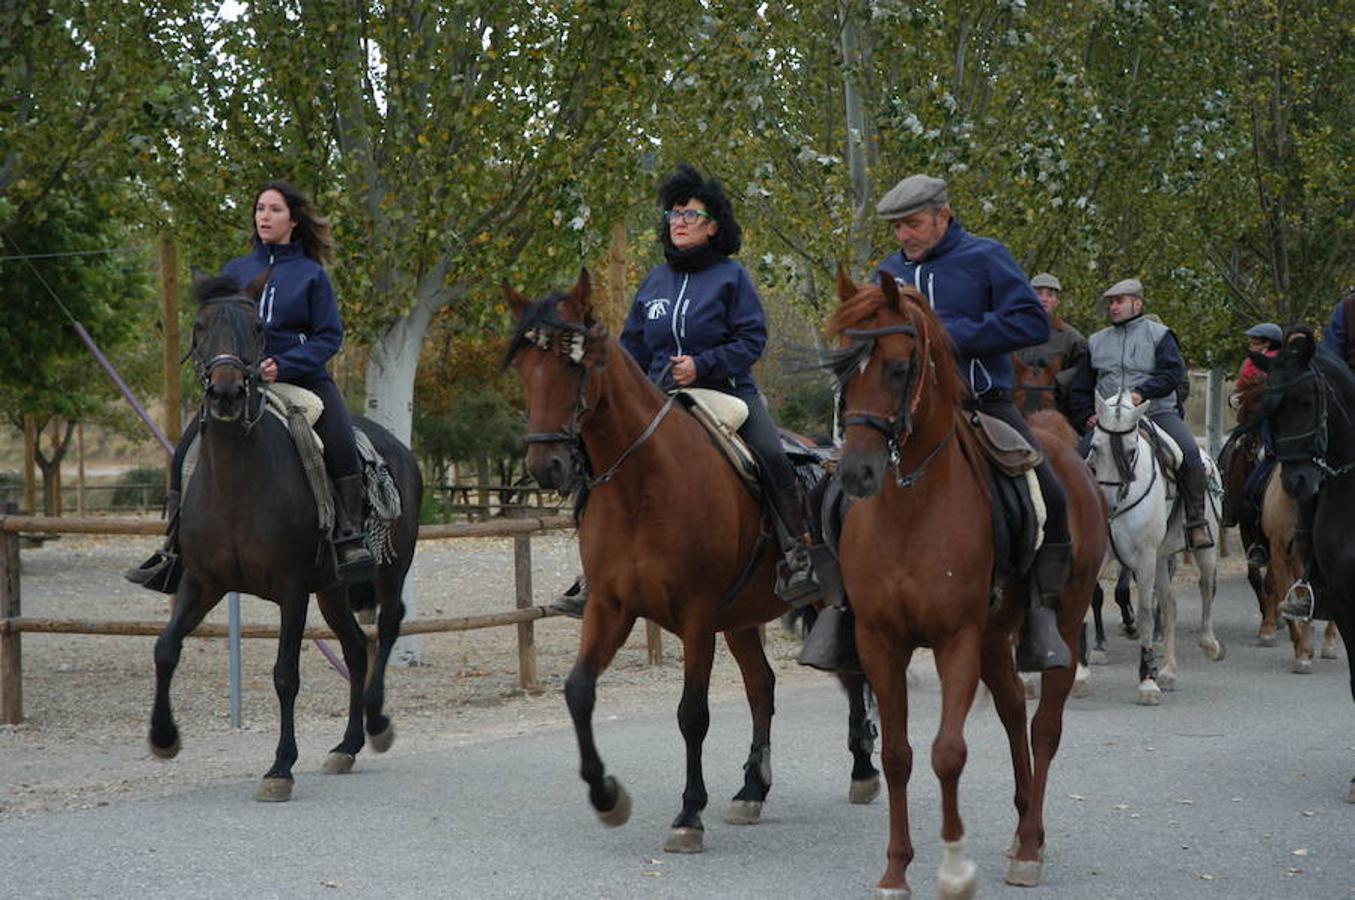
188, 270, 272, 428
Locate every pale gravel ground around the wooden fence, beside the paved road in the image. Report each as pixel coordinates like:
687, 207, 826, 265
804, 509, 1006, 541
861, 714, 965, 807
0, 533, 829, 820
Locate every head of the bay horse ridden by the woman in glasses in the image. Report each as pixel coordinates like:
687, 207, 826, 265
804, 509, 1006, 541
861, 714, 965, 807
504, 268, 607, 493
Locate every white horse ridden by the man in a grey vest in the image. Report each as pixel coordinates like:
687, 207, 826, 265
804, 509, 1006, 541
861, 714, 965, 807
1088, 393, 1226, 706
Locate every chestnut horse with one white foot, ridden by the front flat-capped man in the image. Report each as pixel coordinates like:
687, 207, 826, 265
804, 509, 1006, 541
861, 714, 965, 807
829, 275, 1107, 897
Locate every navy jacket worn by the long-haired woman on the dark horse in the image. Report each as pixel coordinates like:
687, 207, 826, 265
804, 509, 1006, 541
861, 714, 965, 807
221, 244, 343, 382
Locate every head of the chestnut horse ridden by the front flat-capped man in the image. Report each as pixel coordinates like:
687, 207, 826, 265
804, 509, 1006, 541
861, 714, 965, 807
822, 270, 963, 497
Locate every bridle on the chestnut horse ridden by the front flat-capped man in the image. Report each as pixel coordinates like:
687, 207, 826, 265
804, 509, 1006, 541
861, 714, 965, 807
837, 314, 955, 488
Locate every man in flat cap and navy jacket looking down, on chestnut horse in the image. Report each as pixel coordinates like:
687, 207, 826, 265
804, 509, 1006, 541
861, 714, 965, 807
875, 175, 1072, 671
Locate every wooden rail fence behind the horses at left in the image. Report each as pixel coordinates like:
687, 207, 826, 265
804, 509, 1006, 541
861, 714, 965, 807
0, 515, 663, 725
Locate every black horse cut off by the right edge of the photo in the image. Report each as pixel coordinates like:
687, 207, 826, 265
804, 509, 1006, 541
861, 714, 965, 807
1252, 327, 1355, 802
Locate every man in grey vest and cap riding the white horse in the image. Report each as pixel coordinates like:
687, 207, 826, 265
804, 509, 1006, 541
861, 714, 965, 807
1069, 278, 1214, 550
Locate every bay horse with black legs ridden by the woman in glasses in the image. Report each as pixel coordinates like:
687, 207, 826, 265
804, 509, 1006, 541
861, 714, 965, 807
505, 270, 878, 853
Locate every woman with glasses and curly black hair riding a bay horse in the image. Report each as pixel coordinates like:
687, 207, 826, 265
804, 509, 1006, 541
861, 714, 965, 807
554, 164, 813, 615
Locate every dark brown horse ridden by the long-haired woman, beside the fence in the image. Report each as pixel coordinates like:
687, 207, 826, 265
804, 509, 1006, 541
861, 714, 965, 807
149, 278, 423, 801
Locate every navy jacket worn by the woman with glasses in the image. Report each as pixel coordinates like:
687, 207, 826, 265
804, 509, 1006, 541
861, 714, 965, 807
621, 259, 767, 398
